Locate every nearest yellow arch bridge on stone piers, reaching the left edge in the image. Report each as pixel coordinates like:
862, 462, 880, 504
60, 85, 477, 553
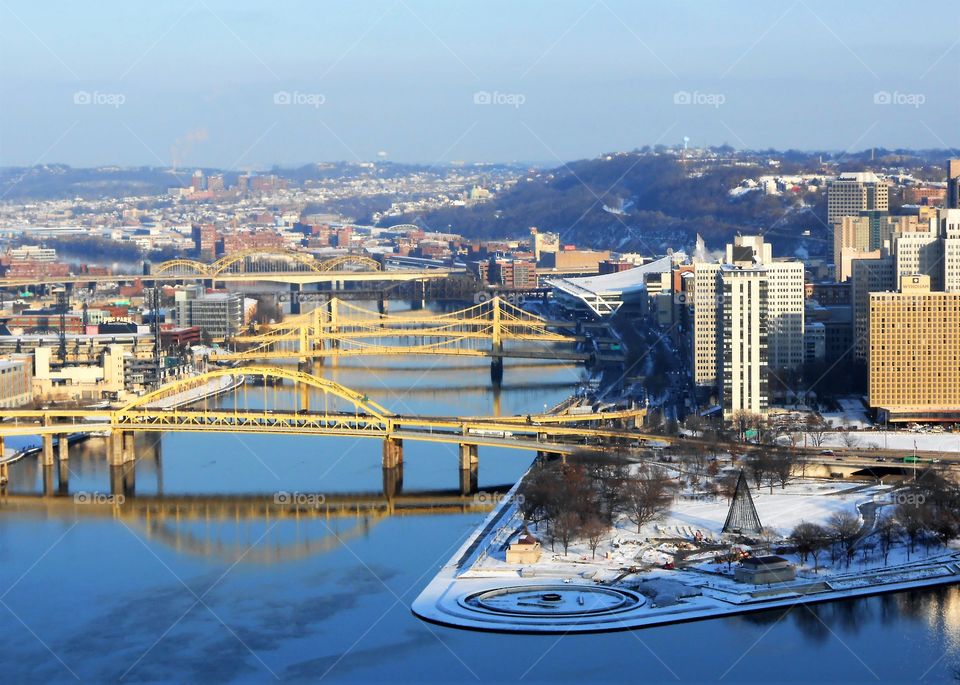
0, 366, 663, 492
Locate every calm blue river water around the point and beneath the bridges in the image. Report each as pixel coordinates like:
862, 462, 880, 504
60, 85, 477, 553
0, 348, 960, 683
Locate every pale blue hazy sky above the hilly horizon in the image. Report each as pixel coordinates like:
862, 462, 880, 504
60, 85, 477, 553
0, 0, 960, 170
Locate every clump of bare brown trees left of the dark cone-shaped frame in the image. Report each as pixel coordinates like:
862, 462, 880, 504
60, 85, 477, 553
520, 454, 674, 556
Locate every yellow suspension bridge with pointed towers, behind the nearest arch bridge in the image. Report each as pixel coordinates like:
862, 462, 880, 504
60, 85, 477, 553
214, 297, 590, 361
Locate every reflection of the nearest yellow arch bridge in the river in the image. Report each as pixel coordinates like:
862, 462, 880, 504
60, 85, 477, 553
0, 485, 511, 564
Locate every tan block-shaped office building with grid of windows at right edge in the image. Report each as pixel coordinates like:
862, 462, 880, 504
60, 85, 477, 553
868, 274, 960, 422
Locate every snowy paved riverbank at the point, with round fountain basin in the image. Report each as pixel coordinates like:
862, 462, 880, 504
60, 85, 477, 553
412, 479, 960, 633
